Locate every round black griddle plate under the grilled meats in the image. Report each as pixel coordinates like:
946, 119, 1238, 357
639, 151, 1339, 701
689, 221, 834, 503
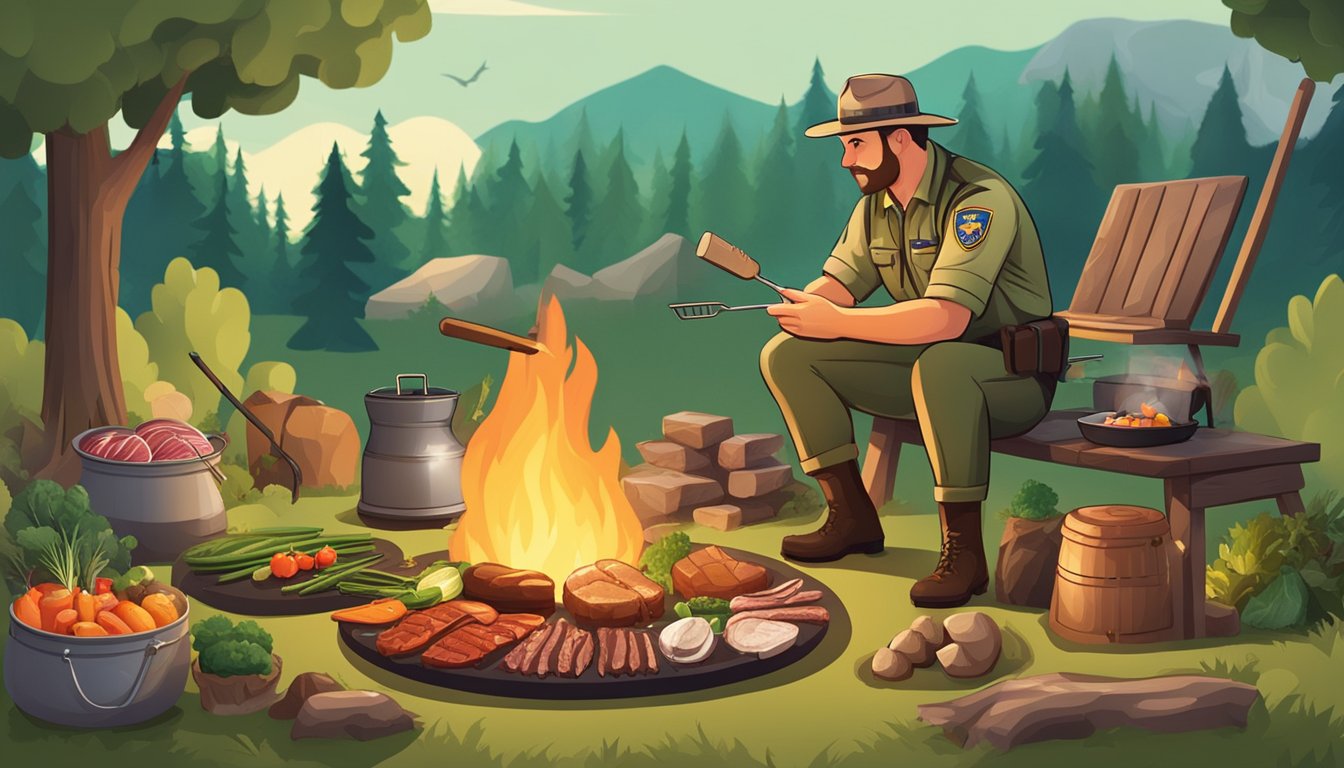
339, 547, 848, 699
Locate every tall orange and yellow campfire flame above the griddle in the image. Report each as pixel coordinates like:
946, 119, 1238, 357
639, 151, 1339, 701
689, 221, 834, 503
449, 296, 644, 597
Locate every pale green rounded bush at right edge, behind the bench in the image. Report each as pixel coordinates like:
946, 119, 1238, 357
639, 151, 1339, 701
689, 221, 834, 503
1235, 274, 1344, 483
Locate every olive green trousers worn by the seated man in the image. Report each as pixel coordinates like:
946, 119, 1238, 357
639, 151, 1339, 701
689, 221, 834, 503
761, 334, 1055, 502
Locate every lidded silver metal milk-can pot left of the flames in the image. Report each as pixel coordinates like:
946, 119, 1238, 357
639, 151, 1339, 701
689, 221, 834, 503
358, 374, 466, 521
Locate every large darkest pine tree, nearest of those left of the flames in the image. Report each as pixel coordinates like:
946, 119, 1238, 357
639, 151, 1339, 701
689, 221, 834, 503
289, 143, 378, 352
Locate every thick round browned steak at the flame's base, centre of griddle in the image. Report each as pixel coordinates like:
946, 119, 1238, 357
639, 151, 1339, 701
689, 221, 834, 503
564, 560, 664, 627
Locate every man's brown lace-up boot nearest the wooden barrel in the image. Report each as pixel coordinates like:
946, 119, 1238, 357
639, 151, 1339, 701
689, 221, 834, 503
910, 502, 989, 608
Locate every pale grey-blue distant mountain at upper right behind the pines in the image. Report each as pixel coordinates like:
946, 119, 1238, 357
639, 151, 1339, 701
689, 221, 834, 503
1020, 19, 1335, 144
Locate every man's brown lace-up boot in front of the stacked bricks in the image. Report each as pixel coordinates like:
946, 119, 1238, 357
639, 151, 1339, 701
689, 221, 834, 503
780, 461, 884, 562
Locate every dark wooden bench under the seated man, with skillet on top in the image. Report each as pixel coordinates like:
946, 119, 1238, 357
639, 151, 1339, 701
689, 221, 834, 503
863, 410, 1321, 639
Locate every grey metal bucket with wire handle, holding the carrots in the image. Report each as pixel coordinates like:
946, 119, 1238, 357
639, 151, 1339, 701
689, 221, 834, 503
4, 605, 191, 728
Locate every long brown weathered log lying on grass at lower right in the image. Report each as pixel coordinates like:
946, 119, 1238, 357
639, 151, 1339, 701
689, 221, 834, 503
919, 673, 1259, 749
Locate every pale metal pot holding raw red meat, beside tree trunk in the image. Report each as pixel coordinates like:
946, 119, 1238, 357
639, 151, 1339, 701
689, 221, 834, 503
73, 428, 228, 562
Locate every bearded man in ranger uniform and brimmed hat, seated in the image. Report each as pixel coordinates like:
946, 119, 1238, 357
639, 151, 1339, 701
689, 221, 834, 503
761, 74, 1055, 607
